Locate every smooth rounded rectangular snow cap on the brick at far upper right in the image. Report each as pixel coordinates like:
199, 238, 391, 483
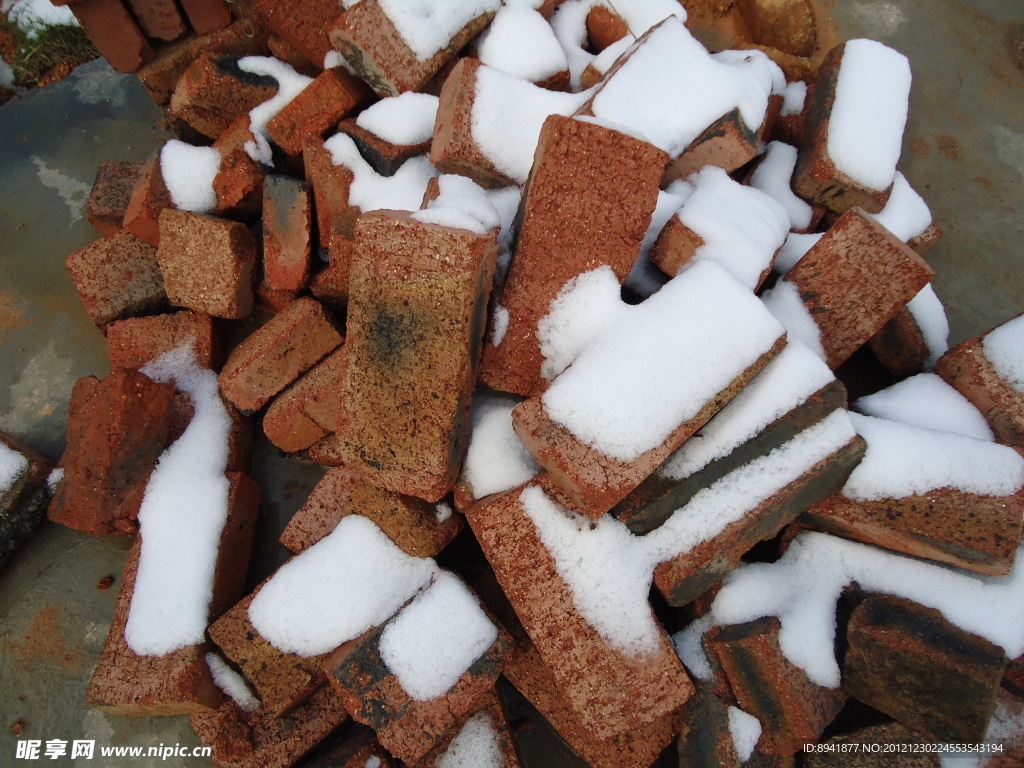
826, 39, 910, 189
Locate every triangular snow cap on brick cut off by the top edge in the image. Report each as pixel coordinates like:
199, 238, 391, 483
378, 0, 501, 61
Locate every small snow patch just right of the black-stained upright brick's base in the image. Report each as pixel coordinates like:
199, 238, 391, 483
462, 392, 541, 499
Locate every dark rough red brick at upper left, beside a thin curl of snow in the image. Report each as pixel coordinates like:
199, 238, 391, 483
168, 54, 278, 138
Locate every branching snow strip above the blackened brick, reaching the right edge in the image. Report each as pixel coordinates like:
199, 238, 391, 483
708, 532, 1024, 688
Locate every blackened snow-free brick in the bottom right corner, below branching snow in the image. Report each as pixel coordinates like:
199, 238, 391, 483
843, 595, 1006, 743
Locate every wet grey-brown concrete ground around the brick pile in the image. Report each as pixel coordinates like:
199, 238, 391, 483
0, 0, 1024, 768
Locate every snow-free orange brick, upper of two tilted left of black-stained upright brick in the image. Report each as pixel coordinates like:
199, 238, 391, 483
220, 298, 342, 411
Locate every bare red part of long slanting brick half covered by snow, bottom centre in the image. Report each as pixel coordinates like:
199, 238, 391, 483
466, 480, 693, 741
